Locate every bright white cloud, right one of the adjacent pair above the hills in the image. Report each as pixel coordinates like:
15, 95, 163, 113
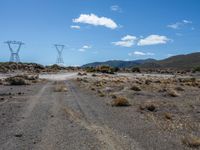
137, 35, 169, 46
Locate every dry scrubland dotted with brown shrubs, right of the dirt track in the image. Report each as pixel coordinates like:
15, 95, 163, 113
77, 72, 200, 148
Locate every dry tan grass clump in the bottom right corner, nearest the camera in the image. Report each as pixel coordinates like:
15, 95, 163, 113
182, 135, 200, 148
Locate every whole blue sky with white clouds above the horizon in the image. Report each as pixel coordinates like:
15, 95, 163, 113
0, 0, 200, 65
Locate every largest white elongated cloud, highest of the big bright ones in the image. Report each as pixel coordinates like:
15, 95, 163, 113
72, 14, 118, 29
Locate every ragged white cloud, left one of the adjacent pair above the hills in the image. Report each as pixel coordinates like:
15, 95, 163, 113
112, 35, 137, 47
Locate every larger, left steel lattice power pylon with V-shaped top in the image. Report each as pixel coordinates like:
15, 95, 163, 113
5, 41, 24, 63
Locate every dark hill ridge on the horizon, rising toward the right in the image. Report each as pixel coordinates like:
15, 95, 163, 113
82, 52, 200, 69
